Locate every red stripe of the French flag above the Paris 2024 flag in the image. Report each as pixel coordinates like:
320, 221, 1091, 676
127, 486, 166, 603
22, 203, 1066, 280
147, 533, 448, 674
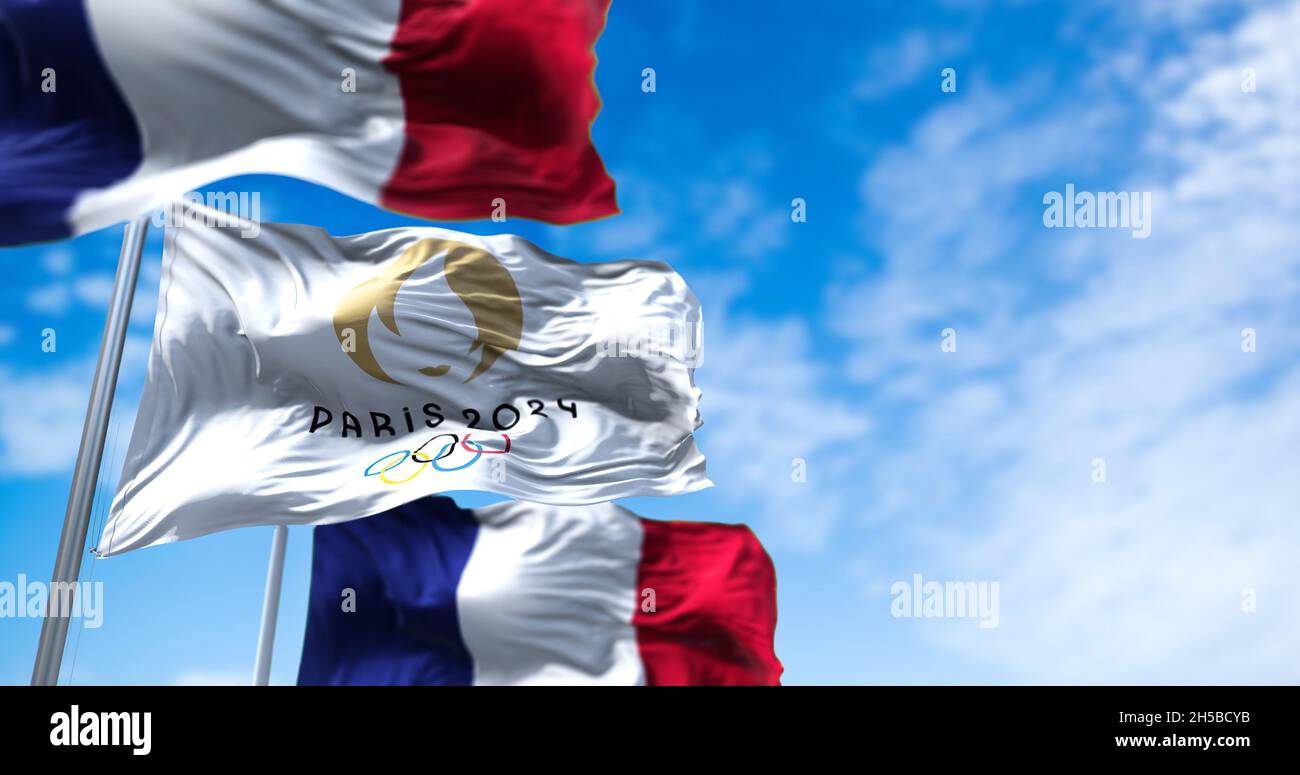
380, 0, 619, 224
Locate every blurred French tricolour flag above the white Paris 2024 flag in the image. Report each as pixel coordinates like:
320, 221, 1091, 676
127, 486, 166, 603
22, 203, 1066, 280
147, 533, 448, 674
0, 0, 618, 244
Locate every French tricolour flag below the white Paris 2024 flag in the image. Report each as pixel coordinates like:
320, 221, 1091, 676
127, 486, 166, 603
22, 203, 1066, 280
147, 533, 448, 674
298, 498, 781, 685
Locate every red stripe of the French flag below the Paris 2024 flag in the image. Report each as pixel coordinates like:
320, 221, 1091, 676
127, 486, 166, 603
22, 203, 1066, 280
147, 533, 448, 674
632, 519, 783, 685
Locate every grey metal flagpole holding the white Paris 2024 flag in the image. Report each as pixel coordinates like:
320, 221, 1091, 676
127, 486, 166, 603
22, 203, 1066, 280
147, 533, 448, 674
31, 216, 150, 687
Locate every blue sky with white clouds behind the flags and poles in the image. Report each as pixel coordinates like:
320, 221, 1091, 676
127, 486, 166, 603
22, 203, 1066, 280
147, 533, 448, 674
0, 0, 1300, 684
